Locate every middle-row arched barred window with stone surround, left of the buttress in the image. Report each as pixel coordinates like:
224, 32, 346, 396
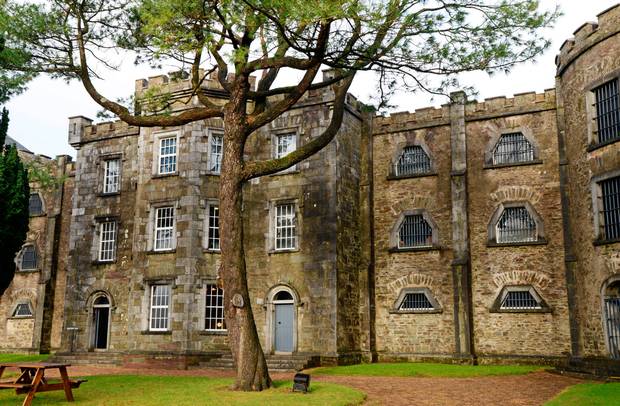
390, 209, 439, 251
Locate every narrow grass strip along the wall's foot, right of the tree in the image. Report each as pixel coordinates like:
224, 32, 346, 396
312, 362, 544, 378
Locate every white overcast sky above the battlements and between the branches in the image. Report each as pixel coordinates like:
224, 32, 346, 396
7, 0, 619, 157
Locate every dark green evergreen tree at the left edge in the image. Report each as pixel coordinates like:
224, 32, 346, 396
0, 109, 30, 296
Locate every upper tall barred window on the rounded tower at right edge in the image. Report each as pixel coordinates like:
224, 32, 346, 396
593, 79, 620, 144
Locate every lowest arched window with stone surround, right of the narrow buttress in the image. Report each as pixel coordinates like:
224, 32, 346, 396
491, 285, 551, 313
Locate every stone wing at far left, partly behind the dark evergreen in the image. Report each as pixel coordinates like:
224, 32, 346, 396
0, 141, 73, 352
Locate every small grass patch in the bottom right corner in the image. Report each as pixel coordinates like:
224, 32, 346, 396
545, 383, 620, 406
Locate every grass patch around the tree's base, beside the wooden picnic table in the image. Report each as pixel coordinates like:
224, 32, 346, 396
0, 375, 365, 406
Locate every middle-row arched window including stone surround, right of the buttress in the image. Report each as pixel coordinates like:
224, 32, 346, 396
488, 202, 546, 245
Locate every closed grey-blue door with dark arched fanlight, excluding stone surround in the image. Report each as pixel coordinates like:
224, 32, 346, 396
273, 290, 295, 353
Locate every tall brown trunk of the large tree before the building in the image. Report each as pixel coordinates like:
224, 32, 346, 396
219, 81, 271, 391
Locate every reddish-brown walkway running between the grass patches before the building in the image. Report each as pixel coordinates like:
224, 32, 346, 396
37, 365, 583, 406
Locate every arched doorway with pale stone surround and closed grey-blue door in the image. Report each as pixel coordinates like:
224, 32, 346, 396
268, 286, 298, 354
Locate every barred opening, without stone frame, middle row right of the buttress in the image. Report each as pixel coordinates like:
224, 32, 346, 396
495, 206, 538, 243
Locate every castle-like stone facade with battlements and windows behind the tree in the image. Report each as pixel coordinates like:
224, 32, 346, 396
0, 6, 620, 368
